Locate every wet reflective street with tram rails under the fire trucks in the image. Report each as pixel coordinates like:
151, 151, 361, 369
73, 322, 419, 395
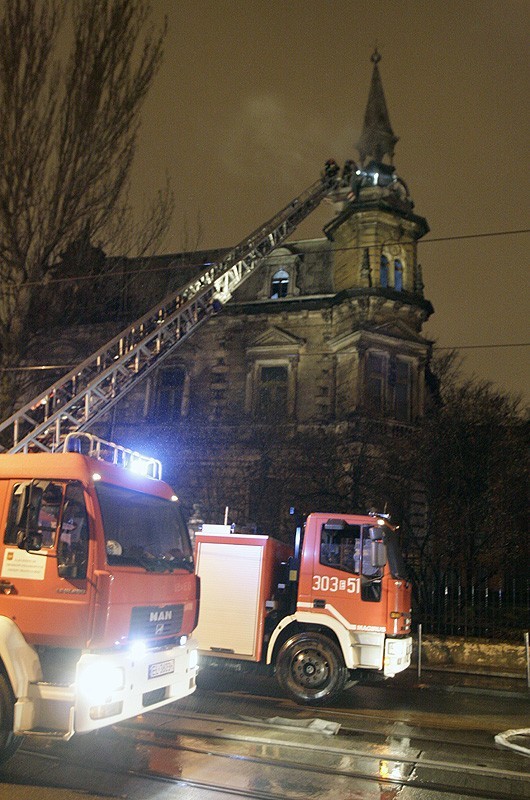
0, 674, 530, 800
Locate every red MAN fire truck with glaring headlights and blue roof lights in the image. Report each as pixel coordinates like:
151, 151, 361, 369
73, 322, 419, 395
0, 433, 199, 760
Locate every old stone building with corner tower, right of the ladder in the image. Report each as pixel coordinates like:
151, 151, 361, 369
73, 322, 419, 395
87, 52, 433, 529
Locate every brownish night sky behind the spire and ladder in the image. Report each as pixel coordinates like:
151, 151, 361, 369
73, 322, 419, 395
129, 0, 530, 394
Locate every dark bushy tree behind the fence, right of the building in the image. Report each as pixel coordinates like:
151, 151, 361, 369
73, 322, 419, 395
389, 352, 528, 616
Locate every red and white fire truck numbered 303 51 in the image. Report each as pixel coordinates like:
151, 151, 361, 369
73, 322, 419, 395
195, 513, 412, 705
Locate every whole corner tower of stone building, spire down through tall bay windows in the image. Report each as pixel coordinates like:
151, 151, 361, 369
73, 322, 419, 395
324, 49, 433, 423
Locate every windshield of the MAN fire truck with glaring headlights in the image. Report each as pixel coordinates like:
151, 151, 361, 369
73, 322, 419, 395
96, 483, 193, 572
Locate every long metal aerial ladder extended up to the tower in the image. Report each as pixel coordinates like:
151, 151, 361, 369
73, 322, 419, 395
0, 161, 339, 453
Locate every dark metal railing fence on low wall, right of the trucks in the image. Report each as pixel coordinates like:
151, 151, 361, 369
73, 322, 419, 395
413, 576, 530, 641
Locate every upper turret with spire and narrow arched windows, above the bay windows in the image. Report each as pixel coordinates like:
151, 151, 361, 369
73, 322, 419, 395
324, 50, 433, 331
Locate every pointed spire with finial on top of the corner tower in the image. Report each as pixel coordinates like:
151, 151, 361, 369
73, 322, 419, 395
357, 47, 398, 166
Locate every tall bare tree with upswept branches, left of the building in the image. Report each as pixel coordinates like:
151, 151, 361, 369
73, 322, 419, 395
0, 0, 172, 414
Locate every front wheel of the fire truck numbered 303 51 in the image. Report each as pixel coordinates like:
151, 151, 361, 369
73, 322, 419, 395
276, 633, 348, 705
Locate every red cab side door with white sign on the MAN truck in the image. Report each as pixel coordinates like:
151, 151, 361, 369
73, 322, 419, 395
0, 478, 91, 647
